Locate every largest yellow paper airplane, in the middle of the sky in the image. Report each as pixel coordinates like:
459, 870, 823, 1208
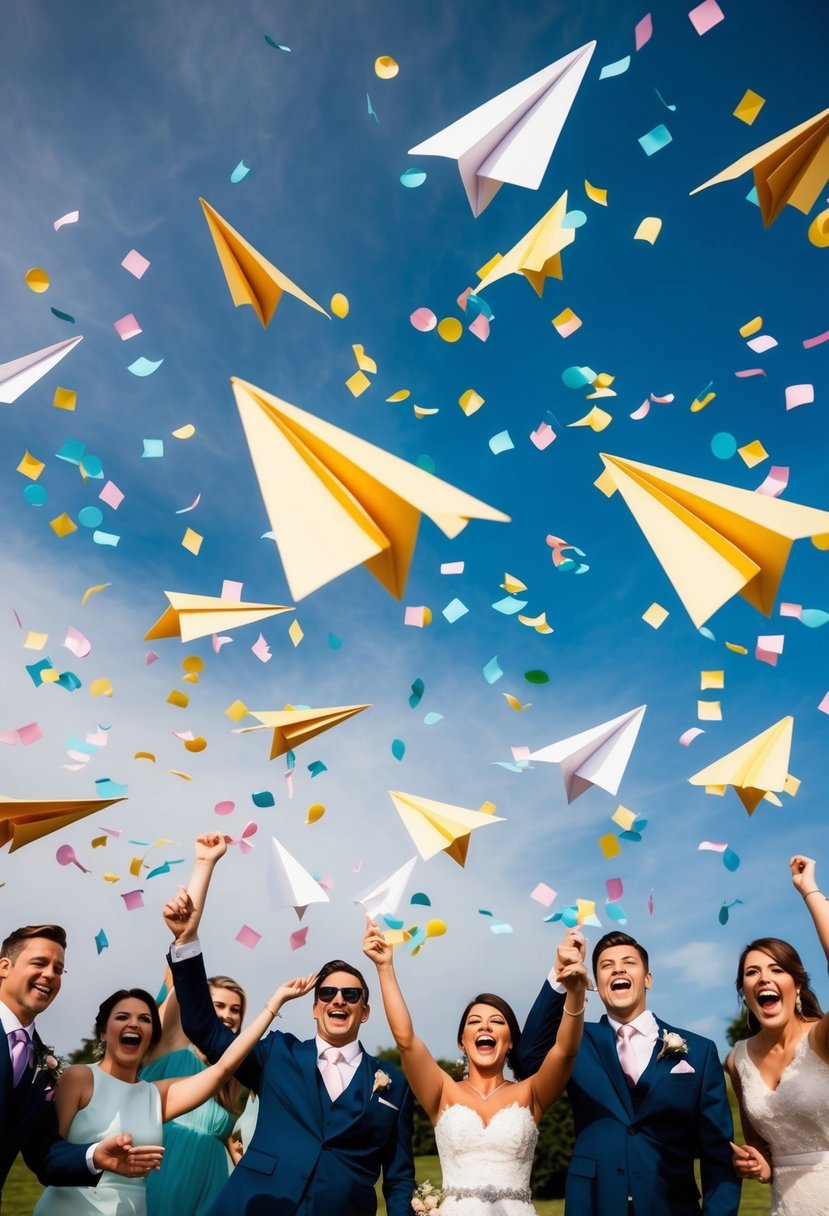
231, 377, 509, 599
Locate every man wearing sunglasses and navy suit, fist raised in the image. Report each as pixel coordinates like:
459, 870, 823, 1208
164, 833, 415, 1216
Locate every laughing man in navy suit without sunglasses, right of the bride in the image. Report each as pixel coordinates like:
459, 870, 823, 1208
518, 933, 740, 1216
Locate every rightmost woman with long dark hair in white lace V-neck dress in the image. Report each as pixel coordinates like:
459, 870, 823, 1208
726, 855, 829, 1216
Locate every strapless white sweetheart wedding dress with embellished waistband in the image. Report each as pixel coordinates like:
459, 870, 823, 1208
435, 1102, 538, 1216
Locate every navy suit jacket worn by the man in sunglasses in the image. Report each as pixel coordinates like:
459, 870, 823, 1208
171, 955, 415, 1216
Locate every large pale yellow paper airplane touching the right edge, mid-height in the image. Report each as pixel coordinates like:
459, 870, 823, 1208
597, 452, 829, 629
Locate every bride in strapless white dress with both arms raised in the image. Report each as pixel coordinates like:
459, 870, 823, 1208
363, 921, 587, 1216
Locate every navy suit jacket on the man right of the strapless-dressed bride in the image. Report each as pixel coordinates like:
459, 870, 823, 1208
519, 983, 740, 1216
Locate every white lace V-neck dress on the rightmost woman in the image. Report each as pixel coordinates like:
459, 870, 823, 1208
734, 1035, 829, 1216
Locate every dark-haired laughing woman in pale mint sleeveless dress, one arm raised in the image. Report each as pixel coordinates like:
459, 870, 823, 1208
34, 974, 314, 1216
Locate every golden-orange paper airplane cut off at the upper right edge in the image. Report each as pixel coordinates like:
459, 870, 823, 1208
692, 109, 829, 227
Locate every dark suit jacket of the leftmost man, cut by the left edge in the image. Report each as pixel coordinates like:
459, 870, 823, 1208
0, 1031, 91, 1190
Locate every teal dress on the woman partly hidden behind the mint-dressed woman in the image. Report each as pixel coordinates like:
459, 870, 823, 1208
141, 1047, 236, 1216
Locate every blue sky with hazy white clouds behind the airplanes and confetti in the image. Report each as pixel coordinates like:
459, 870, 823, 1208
0, 0, 829, 1054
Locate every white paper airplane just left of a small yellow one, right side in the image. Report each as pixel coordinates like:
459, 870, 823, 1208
529, 705, 648, 803
